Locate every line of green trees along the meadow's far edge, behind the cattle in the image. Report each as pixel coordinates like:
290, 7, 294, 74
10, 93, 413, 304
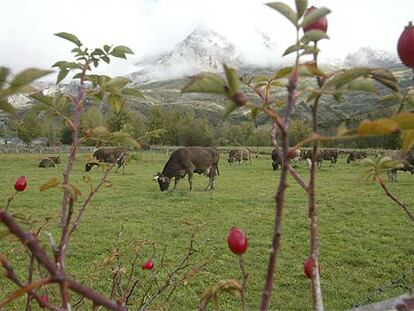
0, 103, 399, 149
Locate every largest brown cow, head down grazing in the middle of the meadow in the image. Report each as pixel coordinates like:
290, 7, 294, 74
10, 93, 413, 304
154, 147, 220, 191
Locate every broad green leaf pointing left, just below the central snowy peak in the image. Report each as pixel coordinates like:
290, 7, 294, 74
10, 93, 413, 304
181, 73, 228, 95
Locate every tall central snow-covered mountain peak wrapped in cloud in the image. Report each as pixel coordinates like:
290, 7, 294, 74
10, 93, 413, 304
131, 27, 276, 82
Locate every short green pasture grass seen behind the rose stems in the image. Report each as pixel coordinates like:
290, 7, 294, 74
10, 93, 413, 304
0, 152, 414, 310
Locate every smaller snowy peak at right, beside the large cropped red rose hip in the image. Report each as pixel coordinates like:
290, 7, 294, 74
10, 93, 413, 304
343, 47, 400, 67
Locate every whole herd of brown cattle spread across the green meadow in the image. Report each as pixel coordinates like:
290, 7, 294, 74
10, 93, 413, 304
39, 147, 414, 191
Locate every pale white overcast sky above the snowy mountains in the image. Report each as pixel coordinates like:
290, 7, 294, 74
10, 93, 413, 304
0, 0, 414, 74
